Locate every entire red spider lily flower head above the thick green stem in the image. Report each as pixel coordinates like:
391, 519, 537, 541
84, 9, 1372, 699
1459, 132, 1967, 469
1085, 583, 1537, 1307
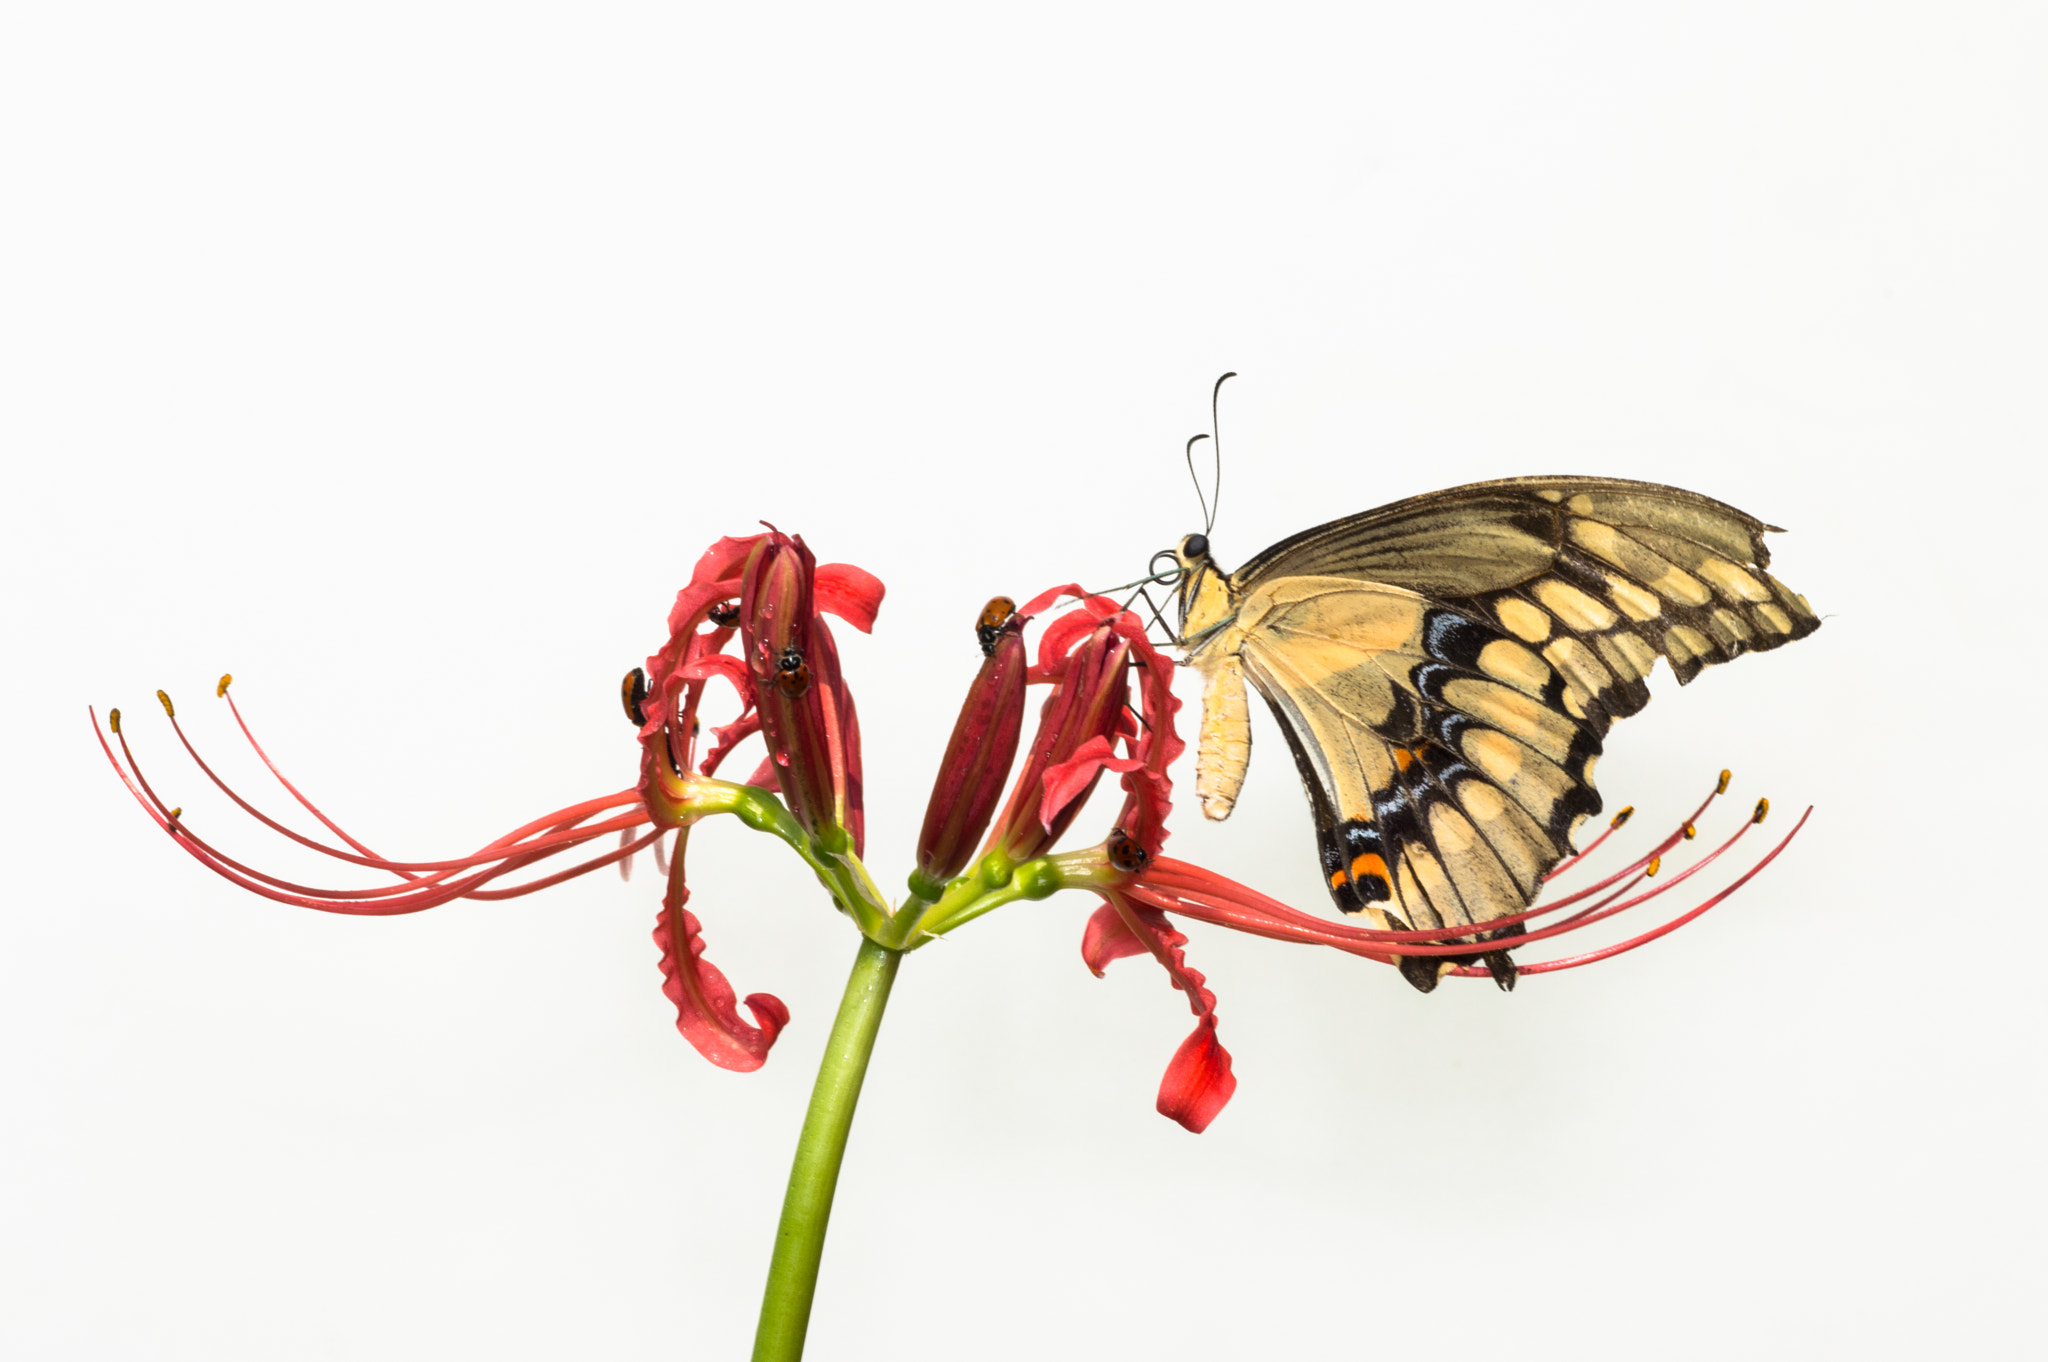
94, 528, 1804, 1131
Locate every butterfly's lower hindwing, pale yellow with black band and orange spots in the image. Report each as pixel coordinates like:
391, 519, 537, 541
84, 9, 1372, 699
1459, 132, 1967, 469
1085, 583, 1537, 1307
1239, 578, 1599, 979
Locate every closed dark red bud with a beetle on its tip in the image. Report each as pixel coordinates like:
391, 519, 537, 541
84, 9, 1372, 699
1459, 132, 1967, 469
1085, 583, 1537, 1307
909, 596, 1030, 899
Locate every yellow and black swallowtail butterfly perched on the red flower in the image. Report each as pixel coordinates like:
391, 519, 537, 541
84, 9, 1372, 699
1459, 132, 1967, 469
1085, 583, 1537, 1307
1171, 477, 1821, 993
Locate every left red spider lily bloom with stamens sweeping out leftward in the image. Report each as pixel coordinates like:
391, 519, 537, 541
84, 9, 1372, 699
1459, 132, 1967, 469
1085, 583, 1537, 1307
94, 533, 883, 1069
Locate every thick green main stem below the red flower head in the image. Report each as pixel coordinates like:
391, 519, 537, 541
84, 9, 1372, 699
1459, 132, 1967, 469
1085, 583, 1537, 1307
754, 938, 903, 1362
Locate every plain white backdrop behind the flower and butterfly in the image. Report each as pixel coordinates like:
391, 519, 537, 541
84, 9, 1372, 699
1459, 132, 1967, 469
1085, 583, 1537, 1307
0, 4, 2048, 1360
